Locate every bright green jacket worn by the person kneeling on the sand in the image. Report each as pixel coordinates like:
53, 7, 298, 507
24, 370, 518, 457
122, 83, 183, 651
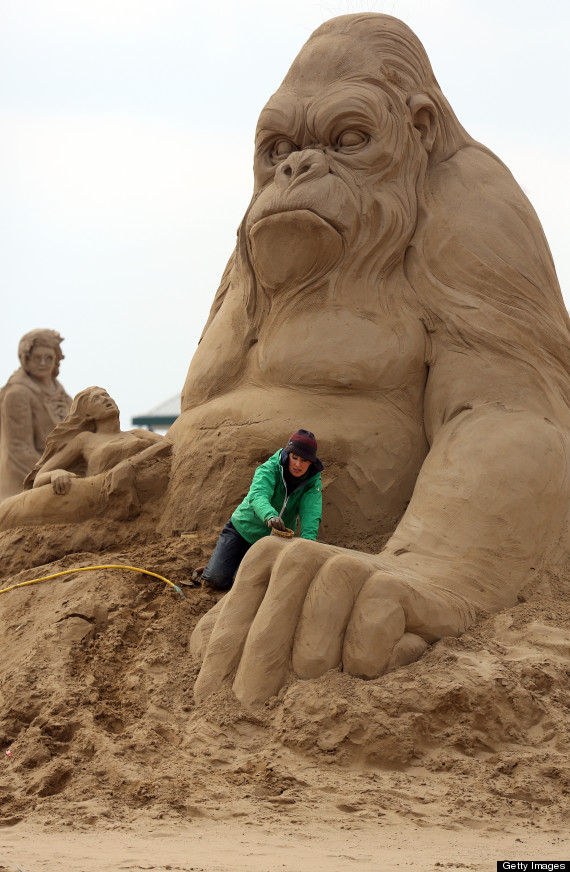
231, 448, 323, 544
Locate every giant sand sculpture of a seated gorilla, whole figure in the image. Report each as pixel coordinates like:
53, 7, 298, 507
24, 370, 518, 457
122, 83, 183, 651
160, 14, 570, 704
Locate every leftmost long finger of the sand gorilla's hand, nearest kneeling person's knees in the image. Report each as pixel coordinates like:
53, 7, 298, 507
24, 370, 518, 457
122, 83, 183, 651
194, 536, 288, 702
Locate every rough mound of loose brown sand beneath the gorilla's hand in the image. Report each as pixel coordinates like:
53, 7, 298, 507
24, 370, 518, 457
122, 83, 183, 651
0, 524, 570, 830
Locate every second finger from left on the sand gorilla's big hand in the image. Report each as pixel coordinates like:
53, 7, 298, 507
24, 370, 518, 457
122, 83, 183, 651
234, 539, 331, 705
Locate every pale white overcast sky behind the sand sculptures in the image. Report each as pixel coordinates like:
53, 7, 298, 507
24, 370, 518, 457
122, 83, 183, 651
0, 0, 570, 428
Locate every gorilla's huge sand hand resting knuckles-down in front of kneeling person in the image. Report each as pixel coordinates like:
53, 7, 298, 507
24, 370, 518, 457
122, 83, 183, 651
191, 536, 474, 705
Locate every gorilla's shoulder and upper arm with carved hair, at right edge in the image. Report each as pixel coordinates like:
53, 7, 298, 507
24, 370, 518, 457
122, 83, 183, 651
412, 145, 570, 418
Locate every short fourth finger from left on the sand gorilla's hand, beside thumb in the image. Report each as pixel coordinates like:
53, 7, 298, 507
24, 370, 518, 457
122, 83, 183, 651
342, 572, 406, 678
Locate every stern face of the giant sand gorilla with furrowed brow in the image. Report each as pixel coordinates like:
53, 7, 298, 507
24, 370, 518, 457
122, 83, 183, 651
246, 41, 422, 290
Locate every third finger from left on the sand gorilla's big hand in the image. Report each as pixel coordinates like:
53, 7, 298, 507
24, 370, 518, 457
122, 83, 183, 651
293, 554, 374, 678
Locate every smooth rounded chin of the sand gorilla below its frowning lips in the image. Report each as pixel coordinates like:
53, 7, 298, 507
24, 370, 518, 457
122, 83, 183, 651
245, 209, 344, 290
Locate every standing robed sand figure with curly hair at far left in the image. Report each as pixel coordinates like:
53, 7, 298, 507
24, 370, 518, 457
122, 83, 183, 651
0, 329, 71, 500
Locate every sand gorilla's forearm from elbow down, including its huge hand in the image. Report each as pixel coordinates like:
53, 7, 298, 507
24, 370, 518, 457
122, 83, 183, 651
195, 407, 567, 704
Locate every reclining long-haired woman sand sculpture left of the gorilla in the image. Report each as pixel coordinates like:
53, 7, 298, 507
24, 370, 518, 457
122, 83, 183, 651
0, 386, 170, 529
